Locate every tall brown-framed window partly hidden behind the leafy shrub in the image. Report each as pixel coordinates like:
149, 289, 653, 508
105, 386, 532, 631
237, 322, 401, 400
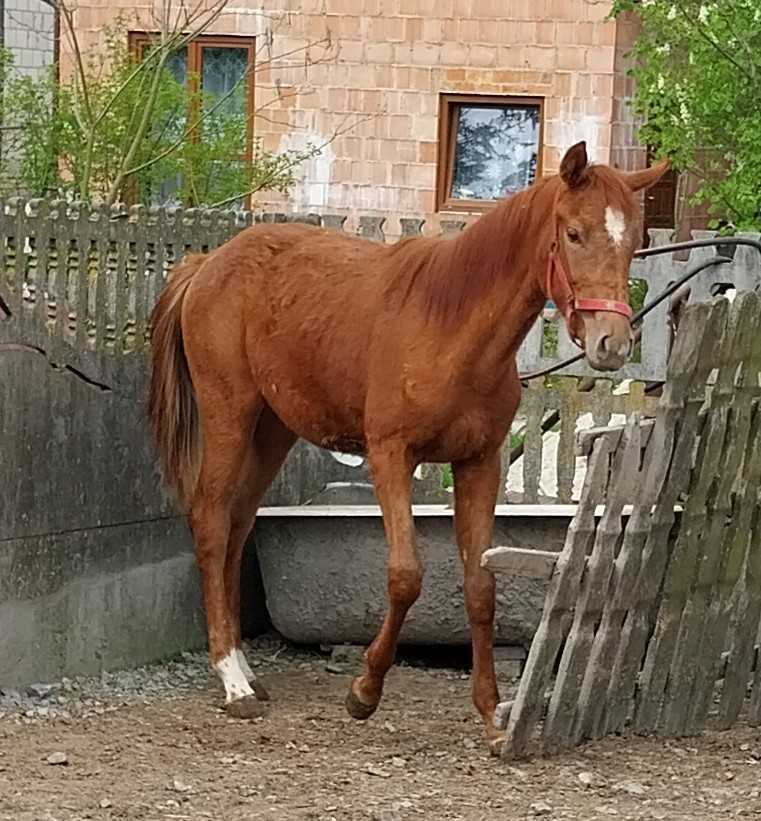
129, 32, 256, 202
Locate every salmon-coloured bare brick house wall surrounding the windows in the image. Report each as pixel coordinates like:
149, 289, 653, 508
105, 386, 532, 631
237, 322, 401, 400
62, 0, 634, 226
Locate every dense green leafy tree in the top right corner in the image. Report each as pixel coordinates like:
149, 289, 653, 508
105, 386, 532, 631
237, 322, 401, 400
612, 0, 761, 230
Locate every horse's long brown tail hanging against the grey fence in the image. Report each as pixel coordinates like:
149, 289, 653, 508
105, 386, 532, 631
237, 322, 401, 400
148, 254, 206, 509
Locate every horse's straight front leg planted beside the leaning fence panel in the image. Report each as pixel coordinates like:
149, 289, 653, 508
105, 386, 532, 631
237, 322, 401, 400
452, 450, 504, 755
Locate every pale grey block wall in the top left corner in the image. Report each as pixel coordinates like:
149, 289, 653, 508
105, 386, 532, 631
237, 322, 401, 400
4, 0, 55, 74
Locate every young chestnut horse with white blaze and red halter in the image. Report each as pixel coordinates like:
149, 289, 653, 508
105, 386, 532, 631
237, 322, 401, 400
150, 143, 667, 751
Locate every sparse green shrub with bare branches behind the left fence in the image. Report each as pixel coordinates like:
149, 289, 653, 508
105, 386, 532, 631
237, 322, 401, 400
0, 0, 350, 207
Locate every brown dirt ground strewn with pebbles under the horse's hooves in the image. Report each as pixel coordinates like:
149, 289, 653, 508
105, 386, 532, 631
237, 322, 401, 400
0, 656, 761, 821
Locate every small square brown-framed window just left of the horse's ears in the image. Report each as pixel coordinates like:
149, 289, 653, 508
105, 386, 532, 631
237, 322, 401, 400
436, 94, 544, 211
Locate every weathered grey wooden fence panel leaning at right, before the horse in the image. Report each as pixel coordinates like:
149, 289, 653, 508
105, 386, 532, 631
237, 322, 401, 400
485, 292, 761, 756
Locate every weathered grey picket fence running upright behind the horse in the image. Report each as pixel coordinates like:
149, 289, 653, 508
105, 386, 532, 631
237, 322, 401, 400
0, 199, 761, 502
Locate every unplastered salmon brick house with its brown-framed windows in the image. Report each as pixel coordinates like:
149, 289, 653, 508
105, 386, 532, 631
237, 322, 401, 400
62, 0, 673, 232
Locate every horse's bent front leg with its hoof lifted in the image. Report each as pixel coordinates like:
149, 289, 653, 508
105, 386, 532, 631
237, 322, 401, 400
346, 442, 423, 721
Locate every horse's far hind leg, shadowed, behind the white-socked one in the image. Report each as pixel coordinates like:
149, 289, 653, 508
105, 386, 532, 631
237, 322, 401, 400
225, 407, 297, 701
